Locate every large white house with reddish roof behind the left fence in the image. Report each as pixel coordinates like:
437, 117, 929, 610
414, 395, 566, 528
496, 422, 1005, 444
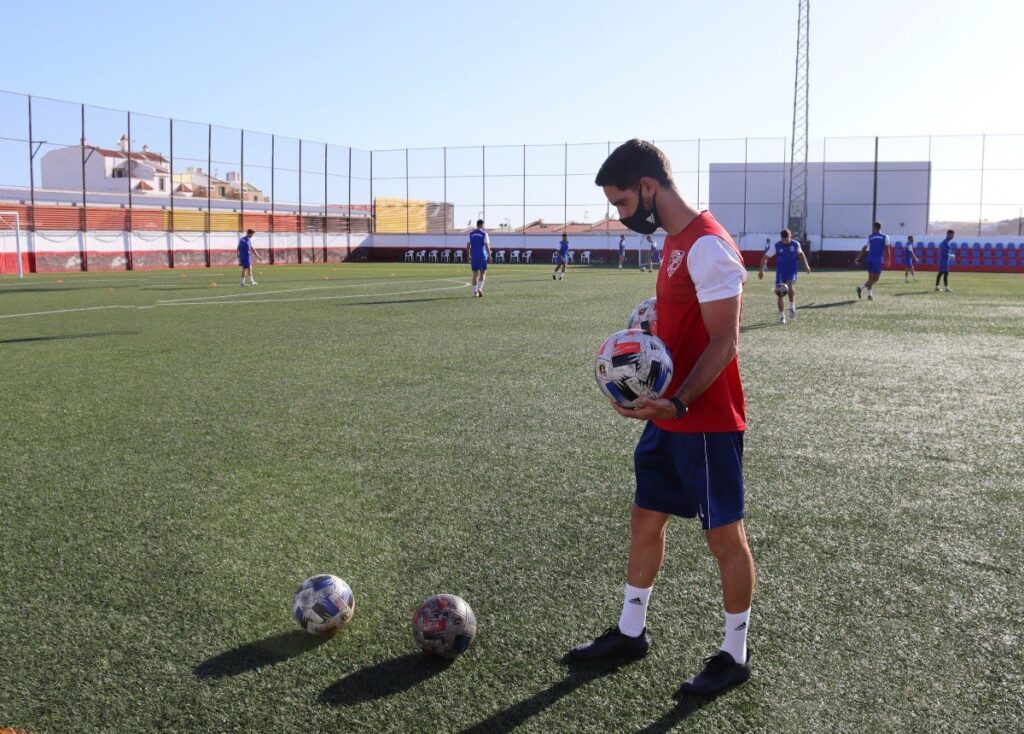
39, 135, 193, 197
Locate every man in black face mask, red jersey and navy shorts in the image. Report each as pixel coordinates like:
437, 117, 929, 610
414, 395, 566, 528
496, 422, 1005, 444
568, 139, 754, 695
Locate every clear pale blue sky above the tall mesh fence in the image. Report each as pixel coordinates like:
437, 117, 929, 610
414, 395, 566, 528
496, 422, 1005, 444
0, 0, 1024, 148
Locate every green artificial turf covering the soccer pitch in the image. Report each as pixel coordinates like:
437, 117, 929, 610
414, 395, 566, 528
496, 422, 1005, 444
0, 264, 1024, 733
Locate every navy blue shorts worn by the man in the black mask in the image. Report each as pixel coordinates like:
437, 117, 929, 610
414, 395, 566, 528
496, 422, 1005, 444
633, 423, 743, 530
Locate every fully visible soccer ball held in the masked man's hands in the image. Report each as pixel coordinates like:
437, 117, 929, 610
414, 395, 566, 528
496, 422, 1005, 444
594, 329, 673, 407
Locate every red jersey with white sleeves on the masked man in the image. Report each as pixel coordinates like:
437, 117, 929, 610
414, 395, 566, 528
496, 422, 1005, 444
654, 212, 746, 433
